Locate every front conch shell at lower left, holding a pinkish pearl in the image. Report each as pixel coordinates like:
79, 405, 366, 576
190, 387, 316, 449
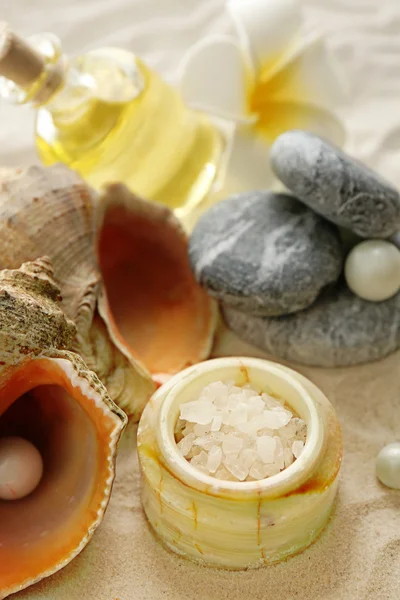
0, 256, 126, 598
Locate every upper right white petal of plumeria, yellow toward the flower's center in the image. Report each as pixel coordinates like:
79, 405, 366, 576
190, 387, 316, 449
256, 35, 347, 110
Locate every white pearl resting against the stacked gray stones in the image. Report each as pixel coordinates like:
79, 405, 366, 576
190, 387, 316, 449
344, 240, 400, 302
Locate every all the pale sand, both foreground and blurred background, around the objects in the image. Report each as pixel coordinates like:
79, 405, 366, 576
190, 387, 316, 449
0, 0, 400, 600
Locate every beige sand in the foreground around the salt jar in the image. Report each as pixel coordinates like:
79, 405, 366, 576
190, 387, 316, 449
15, 324, 400, 600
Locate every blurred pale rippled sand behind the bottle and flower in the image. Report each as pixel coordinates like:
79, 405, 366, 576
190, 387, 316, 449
0, 0, 400, 190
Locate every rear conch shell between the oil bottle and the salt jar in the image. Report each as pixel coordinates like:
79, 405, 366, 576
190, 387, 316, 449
0, 165, 216, 418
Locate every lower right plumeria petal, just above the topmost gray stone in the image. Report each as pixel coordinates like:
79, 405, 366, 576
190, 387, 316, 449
254, 102, 346, 148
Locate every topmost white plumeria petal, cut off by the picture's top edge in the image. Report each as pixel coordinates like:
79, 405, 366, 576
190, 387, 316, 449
227, 0, 302, 71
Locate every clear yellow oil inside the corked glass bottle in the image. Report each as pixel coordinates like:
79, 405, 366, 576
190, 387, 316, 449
36, 55, 224, 214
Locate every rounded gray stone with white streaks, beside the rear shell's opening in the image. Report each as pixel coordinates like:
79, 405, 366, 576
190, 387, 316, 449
189, 192, 343, 316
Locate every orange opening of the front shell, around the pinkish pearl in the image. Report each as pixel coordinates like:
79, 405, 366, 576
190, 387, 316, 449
0, 359, 119, 596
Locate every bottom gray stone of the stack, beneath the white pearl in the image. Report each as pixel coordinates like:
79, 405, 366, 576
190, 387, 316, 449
223, 284, 400, 367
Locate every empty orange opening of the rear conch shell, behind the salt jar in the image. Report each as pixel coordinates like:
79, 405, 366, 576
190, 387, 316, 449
99, 205, 214, 373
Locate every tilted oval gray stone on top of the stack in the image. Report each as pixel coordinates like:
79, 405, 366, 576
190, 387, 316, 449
271, 131, 400, 237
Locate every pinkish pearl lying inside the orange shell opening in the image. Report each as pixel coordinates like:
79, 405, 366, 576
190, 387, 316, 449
0, 437, 43, 500
